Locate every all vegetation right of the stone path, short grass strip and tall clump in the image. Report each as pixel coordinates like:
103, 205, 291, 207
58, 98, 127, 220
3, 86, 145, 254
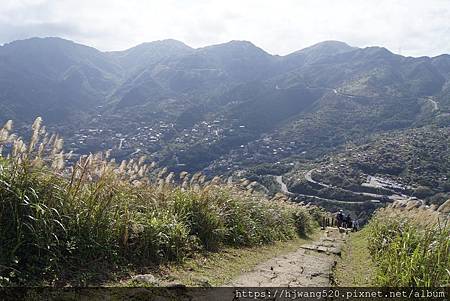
334, 207, 450, 287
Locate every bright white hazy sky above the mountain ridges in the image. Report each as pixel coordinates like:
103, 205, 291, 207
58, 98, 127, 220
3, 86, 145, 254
0, 0, 450, 56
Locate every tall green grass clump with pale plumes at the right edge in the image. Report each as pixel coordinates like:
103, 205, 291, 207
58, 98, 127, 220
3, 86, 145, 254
369, 209, 450, 287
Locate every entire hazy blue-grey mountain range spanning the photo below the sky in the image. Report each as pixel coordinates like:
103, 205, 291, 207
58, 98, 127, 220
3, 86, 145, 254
0, 38, 450, 179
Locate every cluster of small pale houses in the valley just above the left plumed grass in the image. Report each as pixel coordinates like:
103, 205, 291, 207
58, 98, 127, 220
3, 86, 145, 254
66, 115, 253, 166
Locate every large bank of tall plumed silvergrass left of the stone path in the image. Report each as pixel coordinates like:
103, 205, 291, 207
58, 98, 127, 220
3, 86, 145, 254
0, 118, 317, 285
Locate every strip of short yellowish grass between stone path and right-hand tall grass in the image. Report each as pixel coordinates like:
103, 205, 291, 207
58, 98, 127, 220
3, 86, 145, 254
334, 228, 375, 287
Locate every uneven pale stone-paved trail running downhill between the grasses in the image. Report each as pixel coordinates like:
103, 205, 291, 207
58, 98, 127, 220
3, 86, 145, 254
229, 228, 346, 287
